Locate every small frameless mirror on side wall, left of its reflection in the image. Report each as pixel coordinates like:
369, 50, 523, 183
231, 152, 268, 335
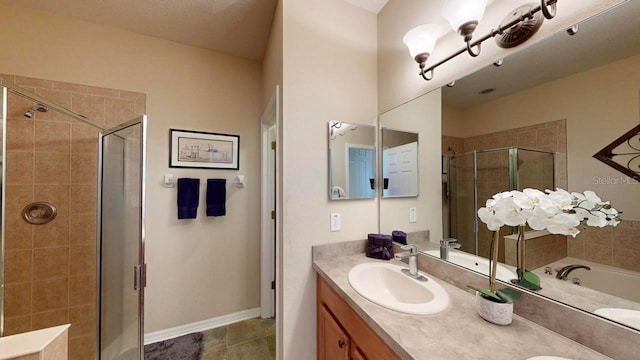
329, 121, 377, 200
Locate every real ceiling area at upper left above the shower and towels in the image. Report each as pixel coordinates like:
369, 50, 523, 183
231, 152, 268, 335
2, 0, 277, 60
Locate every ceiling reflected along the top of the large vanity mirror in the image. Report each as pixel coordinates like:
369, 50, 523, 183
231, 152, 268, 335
442, 0, 640, 108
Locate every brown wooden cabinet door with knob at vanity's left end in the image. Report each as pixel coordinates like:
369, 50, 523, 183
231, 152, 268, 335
318, 306, 350, 360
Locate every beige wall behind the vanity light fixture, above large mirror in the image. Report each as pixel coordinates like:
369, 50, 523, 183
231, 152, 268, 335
378, 0, 622, 112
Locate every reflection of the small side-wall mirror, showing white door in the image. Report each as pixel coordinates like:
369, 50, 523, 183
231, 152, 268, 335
380, 128, 420, 198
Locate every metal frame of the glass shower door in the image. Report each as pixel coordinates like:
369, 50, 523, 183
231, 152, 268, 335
96, 115, 147, 360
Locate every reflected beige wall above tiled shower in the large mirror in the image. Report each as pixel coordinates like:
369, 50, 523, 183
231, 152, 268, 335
450, 55, 640, 220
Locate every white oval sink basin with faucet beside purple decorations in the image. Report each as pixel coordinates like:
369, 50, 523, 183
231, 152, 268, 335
349, 262, 449, 315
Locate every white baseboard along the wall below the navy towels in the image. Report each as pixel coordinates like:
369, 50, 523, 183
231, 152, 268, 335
144, 307, 260, 345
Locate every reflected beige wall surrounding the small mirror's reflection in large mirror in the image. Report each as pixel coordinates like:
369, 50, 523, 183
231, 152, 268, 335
380, 89, 442, 241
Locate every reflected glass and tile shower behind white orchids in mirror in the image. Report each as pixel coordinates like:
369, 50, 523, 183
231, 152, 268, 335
443, 147, 555, 262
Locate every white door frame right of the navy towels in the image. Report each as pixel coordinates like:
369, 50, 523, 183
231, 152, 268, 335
260, 85, 280, 318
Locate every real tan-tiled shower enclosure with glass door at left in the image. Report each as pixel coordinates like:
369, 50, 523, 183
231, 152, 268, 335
0, 75, 146, 360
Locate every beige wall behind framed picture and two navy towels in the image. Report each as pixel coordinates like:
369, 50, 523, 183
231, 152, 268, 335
0, 4, 262, 332
